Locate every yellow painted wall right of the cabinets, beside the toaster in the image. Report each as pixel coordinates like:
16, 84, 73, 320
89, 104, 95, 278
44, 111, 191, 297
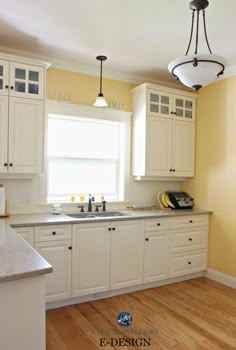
182, 77, 236, 277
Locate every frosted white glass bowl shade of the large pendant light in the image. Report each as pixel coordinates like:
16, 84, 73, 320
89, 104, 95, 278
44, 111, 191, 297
168, 54, 225, 90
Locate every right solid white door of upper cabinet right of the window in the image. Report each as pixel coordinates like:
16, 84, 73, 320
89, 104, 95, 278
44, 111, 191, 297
172, 120, 195, 177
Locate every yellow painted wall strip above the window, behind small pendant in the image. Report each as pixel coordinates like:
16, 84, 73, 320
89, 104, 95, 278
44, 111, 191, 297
47, 68, 136, 111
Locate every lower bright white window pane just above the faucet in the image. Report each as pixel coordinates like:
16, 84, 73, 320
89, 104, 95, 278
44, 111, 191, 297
48, 159, 117, 199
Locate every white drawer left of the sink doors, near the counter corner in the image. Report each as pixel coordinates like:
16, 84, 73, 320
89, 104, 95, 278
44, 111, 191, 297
34, 225, 71, 242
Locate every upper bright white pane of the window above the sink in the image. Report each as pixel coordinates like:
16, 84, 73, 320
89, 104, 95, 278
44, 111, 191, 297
48, 117, 120, 159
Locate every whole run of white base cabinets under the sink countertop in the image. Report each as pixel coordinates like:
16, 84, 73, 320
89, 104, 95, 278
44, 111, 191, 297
12, 215, 208, 302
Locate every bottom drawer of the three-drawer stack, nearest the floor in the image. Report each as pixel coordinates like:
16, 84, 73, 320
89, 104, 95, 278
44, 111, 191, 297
170, 251, 207, 277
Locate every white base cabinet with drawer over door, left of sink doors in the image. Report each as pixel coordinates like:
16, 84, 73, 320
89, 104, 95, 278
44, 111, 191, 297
34, 225, 72, 301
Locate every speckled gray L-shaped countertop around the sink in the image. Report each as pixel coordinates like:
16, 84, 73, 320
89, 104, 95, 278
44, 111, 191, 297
0, 209, 211, 282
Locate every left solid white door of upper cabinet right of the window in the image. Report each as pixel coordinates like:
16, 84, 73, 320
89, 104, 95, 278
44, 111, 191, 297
146, 117, 172, 176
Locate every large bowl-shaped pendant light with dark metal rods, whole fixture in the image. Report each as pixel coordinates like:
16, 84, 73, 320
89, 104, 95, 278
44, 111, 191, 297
168, 0, 225, 91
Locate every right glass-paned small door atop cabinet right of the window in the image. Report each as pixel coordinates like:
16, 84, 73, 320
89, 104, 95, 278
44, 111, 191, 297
173, 95, 195, 122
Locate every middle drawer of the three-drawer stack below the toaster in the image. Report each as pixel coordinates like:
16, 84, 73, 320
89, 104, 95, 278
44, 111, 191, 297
170, 227, 208, 253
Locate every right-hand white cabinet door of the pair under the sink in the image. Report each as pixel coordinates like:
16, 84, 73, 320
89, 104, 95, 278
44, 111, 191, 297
109, 221, 144, 289
